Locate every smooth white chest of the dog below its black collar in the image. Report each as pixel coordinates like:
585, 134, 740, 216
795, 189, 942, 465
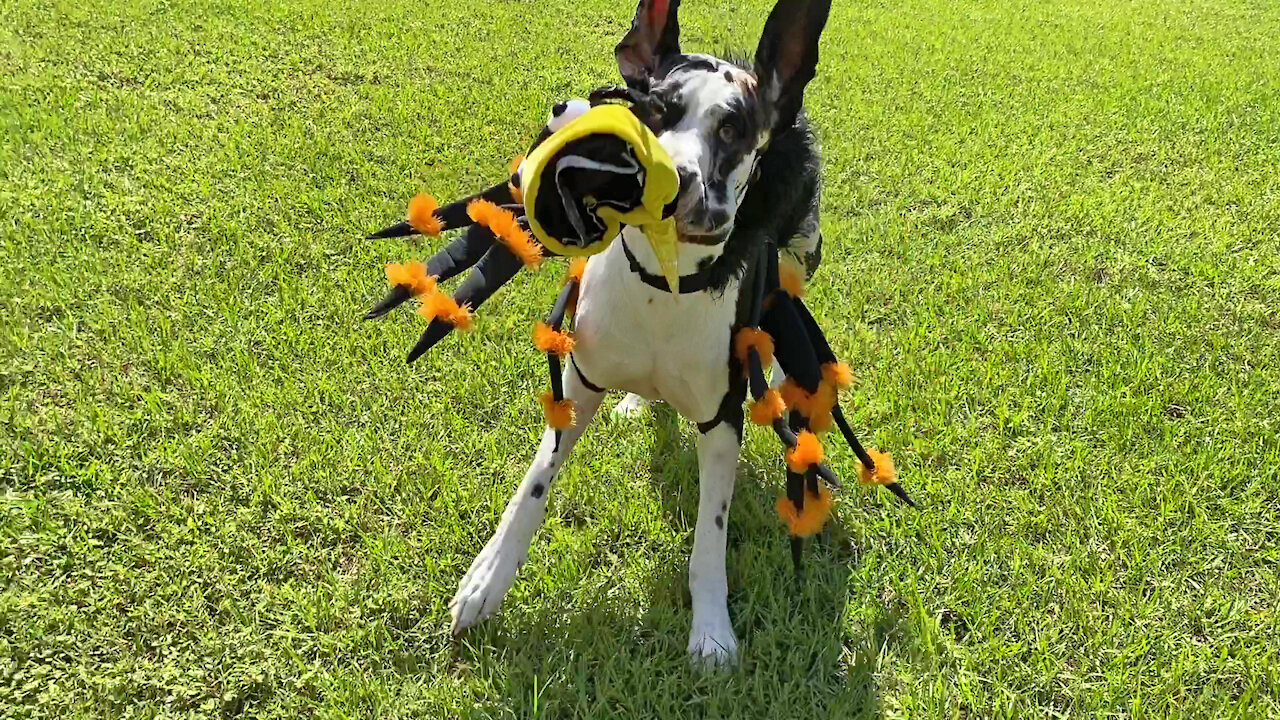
573, 242, 739, 421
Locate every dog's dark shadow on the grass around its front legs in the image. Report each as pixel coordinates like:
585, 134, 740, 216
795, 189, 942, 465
456, 404, 909, 720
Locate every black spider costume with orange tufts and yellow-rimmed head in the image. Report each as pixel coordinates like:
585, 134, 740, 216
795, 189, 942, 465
366, 87, 914, 569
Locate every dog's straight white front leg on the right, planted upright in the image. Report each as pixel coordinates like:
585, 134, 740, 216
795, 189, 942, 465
689, 420, 742, 665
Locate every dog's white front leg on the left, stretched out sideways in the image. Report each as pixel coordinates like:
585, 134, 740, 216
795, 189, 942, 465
449, 365, 604, 634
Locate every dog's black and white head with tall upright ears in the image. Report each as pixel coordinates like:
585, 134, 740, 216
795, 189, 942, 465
614, 0, 831, 245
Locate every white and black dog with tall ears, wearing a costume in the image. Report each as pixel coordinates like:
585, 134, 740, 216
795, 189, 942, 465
451, 0, 831, 661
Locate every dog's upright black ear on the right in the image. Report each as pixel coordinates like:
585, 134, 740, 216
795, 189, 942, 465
755, 0, 831, 131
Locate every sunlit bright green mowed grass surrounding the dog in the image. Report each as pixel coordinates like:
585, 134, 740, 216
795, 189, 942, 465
0, 0, 1280, 720
